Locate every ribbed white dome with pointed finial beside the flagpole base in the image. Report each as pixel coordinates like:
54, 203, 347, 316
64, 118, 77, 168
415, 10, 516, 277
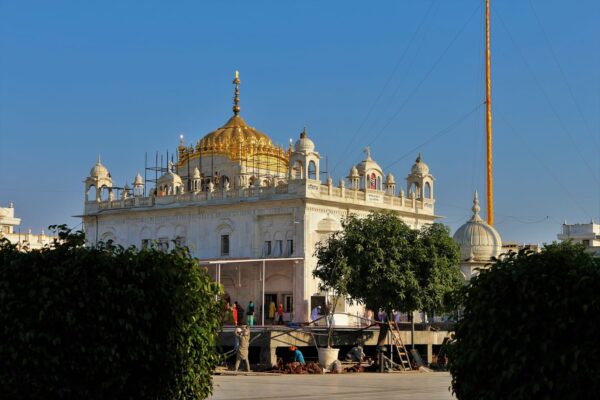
454, 192, 502, 261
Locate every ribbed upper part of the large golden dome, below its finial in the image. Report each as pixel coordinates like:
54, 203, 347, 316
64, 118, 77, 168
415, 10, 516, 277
198, 115, 273, 150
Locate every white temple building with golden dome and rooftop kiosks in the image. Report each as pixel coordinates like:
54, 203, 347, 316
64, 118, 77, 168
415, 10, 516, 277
82, 73, 436, 324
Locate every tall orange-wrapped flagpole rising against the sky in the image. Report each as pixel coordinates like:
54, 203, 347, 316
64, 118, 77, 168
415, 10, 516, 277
485, 0, 494, 225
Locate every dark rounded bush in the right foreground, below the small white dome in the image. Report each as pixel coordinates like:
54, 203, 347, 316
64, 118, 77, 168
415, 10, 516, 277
450, 243, 600, 400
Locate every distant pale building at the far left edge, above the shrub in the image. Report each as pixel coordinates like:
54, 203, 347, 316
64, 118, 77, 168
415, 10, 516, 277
0, 203, 57, 251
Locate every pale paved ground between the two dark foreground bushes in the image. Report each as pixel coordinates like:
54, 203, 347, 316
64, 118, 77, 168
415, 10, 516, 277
209, 372, 454, 400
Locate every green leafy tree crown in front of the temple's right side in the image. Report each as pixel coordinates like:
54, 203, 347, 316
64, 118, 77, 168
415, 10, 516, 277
313, 212, 462, 344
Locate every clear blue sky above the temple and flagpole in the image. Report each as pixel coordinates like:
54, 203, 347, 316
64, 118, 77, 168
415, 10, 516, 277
0, 0, 600, 243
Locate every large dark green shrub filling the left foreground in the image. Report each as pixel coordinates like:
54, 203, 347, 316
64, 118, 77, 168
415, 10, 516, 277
0, 227, 221, 399
